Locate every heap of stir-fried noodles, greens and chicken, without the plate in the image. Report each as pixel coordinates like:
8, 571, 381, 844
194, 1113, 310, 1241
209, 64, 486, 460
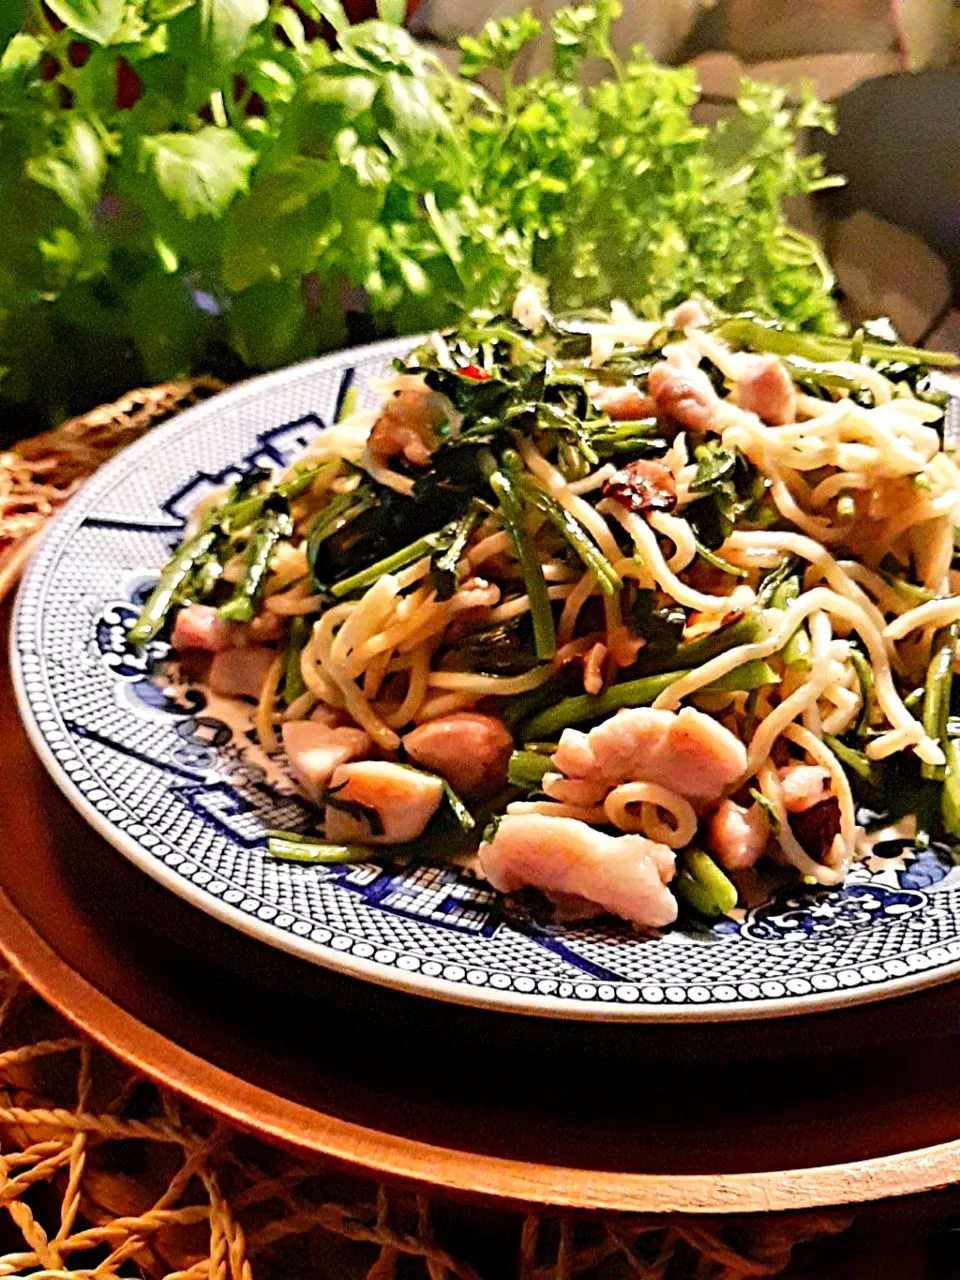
132, 288, 960, 928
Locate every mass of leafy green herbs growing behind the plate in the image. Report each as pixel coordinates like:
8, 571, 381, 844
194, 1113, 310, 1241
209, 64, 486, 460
0, 0, 849, 437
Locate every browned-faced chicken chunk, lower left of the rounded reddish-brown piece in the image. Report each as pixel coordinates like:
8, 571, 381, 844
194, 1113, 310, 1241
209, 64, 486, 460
324, 760, 443, 845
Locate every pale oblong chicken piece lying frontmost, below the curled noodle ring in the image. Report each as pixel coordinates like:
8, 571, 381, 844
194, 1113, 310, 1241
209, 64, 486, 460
479, 814, 677, 928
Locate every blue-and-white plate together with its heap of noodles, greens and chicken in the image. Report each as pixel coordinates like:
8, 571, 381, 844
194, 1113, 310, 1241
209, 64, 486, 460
13, 288, 960, 1020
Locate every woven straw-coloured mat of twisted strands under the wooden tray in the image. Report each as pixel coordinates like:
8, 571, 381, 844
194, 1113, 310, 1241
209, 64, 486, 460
0, 379, 960, 1280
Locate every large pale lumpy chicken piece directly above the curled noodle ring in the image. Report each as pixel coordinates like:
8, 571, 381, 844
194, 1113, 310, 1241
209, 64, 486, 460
553, 707, 746, 805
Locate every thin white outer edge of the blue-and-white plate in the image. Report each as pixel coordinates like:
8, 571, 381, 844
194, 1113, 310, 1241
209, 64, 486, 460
15, 345, 960, 1025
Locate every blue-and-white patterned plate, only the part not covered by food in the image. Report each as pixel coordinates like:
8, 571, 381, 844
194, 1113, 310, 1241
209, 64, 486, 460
13, 339, 960, 1021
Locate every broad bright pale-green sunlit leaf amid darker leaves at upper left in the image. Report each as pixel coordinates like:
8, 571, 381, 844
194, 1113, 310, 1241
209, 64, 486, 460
140, 124, 256, 220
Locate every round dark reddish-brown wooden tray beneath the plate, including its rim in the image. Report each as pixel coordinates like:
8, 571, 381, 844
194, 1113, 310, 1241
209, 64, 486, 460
0, 599, 960, 1213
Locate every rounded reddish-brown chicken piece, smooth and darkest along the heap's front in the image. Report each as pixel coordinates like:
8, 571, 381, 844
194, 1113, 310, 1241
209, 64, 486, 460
402, 712, 513, 799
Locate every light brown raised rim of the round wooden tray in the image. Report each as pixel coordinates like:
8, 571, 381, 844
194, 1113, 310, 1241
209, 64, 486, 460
9, 888, 960, 1217
